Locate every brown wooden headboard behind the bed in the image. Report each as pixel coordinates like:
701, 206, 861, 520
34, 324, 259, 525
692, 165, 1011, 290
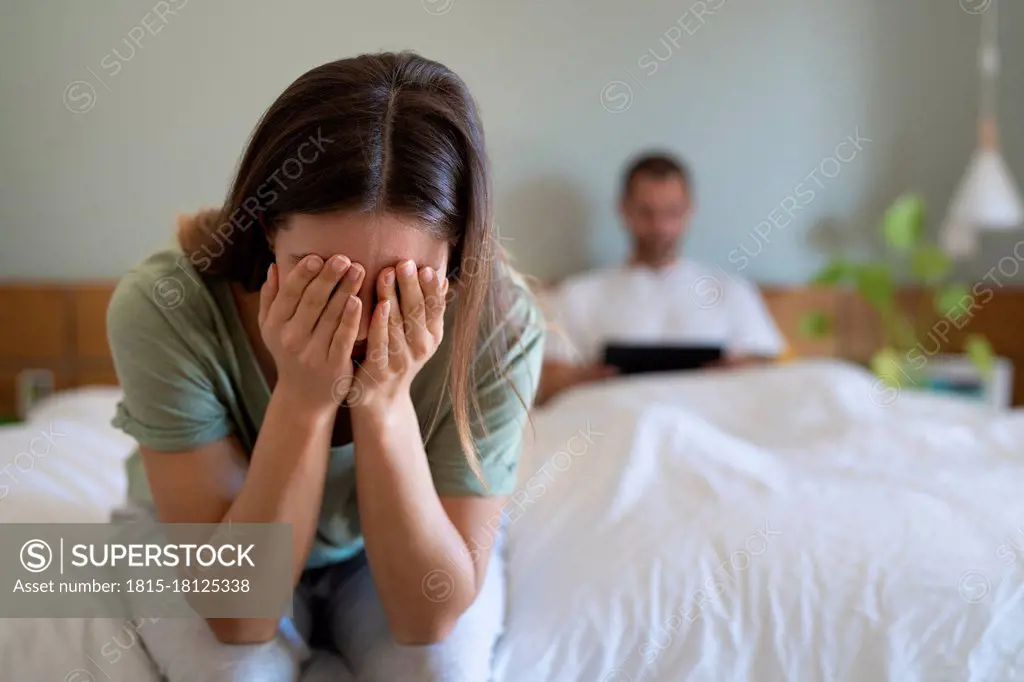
0, 282, 1024, 416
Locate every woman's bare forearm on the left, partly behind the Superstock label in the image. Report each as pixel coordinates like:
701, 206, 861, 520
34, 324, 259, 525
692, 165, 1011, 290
208, 389, 334, 644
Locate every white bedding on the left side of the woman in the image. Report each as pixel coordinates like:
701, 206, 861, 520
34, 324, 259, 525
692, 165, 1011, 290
0, 388, 158, 682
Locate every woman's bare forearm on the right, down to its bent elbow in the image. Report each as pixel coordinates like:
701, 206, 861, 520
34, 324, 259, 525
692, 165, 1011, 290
352, 396, 476, 644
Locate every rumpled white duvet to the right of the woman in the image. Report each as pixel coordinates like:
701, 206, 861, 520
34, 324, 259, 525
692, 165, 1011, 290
497, 363, 1024, 682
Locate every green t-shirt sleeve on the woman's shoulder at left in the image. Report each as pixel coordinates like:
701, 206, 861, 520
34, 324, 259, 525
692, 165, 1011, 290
106, 274, 231, 452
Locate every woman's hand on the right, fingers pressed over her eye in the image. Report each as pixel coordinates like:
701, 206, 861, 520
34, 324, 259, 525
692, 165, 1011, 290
348, 260, 447, 410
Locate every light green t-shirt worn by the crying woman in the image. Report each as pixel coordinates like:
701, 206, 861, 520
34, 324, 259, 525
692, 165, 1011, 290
108, 245, 544, 568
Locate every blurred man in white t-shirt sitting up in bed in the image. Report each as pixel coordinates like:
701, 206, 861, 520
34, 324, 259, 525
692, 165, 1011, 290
538, 153, 785, 403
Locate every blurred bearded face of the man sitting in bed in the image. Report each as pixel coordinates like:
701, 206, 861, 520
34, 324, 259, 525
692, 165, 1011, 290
620, 174, 691, 258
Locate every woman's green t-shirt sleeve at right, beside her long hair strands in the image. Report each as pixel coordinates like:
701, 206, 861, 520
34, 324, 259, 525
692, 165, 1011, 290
425, 292, 545, 497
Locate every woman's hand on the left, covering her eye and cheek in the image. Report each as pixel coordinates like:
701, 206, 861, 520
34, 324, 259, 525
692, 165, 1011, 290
259, 256, 365, 412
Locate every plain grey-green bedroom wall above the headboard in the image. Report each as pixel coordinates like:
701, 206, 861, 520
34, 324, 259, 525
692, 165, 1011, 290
0, 0, 1024, 282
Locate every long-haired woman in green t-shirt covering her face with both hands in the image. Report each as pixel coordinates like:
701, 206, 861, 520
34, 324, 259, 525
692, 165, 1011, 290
108, 53, 543, 682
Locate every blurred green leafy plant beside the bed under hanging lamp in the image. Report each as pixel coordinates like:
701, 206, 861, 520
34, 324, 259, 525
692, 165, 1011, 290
801, 194, 995, 385
